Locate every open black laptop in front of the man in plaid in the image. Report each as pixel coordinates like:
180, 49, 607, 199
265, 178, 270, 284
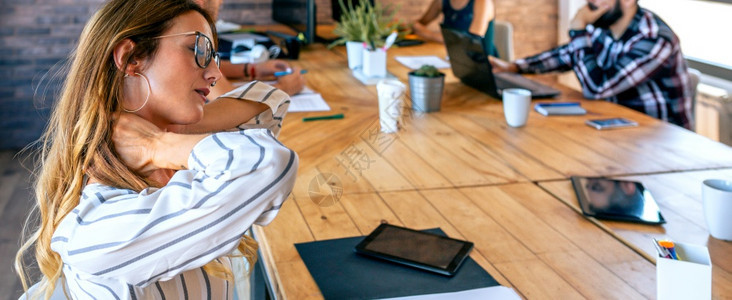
440, 25, 560, 100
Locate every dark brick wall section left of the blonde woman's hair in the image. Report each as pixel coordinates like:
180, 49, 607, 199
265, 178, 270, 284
0, 0, 102, 149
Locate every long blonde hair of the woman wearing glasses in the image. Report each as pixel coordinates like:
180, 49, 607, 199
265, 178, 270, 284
15, 0, 257, 298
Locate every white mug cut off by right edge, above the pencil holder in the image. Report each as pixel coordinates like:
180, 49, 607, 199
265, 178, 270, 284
702, 179, 732, 241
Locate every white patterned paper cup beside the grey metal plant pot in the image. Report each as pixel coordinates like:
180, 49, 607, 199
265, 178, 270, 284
376, 79, 407, 133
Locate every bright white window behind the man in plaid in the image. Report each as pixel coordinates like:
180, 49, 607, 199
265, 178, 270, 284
638, 0, 732, 80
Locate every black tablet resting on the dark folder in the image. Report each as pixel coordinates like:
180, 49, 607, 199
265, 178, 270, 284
355, 223, 473, 276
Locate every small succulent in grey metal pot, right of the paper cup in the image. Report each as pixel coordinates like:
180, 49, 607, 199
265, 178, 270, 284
409, 65, 445, 112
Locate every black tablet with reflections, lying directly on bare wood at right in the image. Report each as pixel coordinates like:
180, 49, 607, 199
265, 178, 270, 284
571, 176, 666, 224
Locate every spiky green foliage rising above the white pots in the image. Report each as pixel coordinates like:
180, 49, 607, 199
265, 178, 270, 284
328, 0, 399, 49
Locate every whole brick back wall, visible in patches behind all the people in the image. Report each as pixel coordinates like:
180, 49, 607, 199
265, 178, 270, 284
0, 0, 557, 149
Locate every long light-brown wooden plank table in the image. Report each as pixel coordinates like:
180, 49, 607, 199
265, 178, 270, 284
249, 44, 732, 299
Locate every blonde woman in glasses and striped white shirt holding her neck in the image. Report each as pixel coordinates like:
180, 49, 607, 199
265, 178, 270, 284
16, 0, 298, 299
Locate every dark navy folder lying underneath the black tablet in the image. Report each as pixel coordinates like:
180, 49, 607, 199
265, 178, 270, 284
295, 228, 498, 299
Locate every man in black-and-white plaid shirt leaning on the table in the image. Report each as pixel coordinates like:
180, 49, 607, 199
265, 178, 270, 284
490, 0, 693, 129
